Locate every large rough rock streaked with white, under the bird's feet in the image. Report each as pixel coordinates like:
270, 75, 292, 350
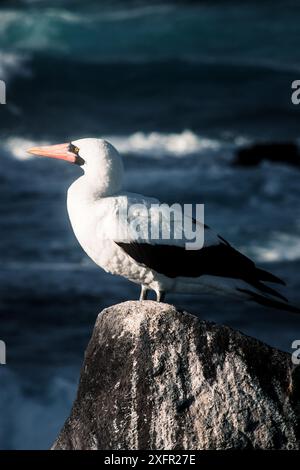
53, 301, 300, 450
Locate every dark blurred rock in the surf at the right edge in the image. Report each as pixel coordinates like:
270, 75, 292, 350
234, 142, 300, 166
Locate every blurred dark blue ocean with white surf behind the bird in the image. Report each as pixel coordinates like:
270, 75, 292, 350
0, 0, 300, 449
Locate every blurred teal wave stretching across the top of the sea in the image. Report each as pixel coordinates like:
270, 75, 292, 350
0, 2, 300, 73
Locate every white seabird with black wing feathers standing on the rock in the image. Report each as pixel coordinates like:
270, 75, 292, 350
28, 138, 300, 313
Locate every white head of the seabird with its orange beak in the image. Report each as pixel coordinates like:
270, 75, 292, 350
28, 138, 123, 196
